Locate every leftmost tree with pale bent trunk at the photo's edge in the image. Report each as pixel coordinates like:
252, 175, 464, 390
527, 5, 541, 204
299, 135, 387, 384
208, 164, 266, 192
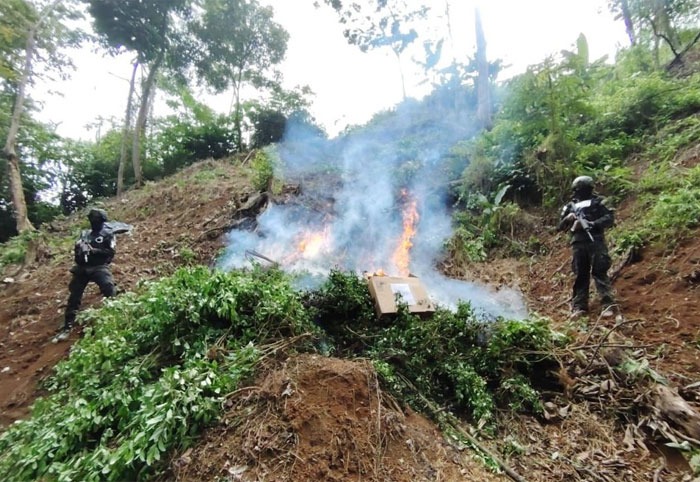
2, 0, 80, 233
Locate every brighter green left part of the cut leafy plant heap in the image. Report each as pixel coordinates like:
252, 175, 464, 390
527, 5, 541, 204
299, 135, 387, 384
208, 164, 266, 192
0, 268, 314, 481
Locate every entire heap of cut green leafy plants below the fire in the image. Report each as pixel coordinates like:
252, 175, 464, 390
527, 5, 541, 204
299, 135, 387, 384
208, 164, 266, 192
0, 268, 556, 481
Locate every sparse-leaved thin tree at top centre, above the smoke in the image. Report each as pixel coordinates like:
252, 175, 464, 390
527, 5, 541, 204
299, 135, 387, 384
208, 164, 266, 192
325, 0, 429, 99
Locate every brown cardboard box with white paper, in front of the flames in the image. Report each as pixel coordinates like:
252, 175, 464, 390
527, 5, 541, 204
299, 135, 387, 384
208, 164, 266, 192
367, 276, 435, 316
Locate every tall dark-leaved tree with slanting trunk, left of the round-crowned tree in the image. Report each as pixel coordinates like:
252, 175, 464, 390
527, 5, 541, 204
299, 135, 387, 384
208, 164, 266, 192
86, 0, 193, 187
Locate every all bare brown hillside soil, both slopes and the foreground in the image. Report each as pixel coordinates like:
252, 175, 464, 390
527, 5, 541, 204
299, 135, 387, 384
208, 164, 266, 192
0, 149, 700, 481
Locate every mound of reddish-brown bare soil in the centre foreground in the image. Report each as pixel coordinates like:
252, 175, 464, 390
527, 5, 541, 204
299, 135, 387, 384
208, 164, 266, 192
173, 355, 502, 482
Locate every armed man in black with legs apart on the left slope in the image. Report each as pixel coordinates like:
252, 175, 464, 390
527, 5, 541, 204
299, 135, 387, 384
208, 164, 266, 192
52, 209, 116, 343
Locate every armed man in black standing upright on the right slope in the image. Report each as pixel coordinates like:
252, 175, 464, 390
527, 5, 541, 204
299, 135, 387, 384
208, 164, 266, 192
559, 176, 615, 317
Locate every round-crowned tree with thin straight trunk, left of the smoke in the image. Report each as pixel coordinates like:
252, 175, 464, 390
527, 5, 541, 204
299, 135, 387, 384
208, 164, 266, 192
194, 0, 289, 150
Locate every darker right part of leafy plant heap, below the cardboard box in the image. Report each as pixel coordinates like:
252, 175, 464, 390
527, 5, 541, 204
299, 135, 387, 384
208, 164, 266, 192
310, 271, 565, 423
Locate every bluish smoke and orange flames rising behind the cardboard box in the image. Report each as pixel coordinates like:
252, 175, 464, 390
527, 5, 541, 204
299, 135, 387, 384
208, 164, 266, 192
220, 118, 526, 318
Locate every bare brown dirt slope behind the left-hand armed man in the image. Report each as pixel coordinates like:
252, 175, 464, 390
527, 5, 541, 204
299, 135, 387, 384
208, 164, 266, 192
0, 162, 253, 426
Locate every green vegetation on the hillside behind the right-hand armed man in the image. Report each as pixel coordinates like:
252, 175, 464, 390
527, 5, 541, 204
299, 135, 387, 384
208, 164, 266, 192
451, 44, 700, 260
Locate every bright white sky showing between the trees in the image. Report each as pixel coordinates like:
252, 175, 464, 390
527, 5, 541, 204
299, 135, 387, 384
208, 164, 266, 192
32, 0, 625, 139
